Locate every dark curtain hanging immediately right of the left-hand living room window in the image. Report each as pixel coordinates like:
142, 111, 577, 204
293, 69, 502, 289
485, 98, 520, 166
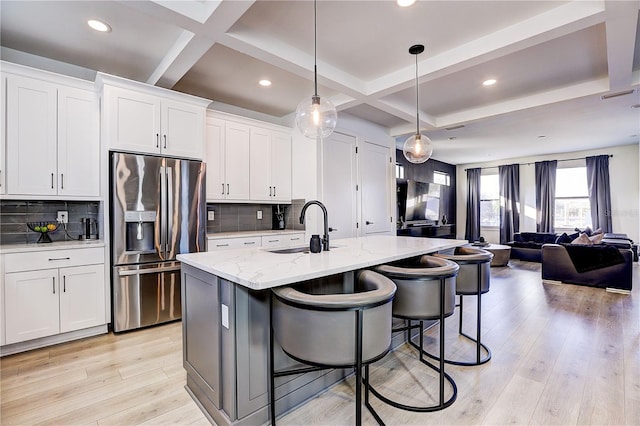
498, 164, 520, 244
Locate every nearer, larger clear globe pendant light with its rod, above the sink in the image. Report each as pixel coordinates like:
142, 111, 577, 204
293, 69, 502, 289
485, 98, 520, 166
296, 0, 338, 139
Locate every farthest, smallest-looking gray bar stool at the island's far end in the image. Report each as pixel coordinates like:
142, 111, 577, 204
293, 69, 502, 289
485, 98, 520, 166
427, 247, 493, 366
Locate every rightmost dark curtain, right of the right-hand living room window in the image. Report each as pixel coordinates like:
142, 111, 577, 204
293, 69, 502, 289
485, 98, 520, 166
586, 155, 613, 233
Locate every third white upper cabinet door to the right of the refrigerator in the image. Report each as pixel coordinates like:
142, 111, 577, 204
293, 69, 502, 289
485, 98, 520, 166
249, 127, 273, 201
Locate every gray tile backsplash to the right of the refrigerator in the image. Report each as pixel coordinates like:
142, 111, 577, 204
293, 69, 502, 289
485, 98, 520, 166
207, 199, 305, 234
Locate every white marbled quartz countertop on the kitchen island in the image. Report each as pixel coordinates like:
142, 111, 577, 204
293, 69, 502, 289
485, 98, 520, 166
178, 235, 468, 290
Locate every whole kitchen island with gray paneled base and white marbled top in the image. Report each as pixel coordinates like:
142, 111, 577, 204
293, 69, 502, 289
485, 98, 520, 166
178, 235, 467, 425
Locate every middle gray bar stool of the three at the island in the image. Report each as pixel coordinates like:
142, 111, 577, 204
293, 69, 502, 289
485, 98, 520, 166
365, 256, 460, 412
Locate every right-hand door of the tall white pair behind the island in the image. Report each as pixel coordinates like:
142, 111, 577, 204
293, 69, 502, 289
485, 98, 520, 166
358, 141, 393, 235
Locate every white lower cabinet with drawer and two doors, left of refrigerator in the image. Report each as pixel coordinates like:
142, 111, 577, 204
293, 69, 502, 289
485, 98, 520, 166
4, 248, 106, 345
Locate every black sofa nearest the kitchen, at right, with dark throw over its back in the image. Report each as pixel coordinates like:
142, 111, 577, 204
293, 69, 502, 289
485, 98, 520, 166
541, 244, 633, 290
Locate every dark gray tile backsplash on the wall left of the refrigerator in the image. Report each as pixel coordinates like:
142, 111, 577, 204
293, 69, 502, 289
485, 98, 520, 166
0, 200, 102, 244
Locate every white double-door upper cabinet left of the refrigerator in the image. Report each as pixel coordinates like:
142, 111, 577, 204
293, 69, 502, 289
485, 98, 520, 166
5, 74, 100, 198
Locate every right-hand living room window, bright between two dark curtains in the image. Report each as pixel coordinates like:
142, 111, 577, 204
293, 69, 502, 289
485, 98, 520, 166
554, 166, 591, 230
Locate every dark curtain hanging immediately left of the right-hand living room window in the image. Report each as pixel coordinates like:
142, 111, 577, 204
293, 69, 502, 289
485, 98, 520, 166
535, 160, 558, 232
